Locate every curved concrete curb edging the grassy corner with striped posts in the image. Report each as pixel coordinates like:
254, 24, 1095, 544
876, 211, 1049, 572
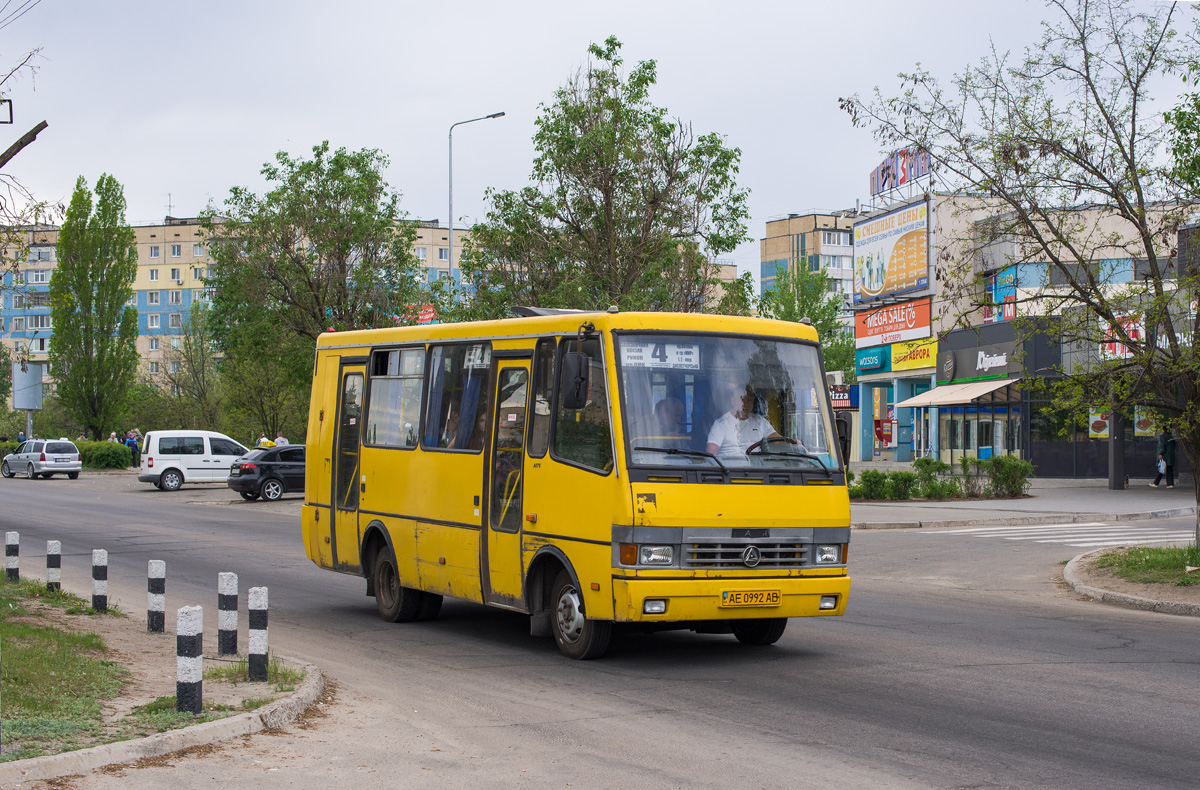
0, 656, 325, 788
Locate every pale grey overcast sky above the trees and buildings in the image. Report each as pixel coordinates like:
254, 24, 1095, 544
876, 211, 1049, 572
0, 0, 1190, 275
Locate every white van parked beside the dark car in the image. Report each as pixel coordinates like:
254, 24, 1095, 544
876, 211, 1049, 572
138, 431, 250, 491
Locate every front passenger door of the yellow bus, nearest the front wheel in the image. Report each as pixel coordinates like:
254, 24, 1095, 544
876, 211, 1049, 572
480, 360, 529, 608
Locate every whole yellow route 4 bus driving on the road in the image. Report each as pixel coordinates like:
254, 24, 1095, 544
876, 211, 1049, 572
304, 309, 850, 659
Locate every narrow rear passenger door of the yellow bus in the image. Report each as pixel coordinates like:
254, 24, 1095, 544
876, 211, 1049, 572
331, 365, 366, 570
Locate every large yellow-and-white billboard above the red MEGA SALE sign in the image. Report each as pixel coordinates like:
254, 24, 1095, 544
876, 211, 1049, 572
854, 203, 929, 304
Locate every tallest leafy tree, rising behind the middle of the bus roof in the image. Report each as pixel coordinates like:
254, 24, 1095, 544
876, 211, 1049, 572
458, 37, 749, 318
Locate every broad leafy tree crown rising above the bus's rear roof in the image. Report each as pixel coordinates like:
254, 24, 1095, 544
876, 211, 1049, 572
200, 140, 424, 341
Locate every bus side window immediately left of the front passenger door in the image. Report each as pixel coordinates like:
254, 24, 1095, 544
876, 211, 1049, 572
422, 343, 492, 450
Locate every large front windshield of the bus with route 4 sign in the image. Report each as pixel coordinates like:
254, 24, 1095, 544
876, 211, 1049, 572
616, 333, 841, 472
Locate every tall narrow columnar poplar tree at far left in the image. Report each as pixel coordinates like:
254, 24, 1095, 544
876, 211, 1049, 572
49, 174, 138, 441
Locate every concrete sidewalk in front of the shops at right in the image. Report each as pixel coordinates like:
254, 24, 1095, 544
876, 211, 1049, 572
850, 477, 1196, 529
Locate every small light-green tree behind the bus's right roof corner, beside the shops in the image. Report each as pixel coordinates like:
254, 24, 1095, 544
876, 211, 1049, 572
758, 262, 854, 383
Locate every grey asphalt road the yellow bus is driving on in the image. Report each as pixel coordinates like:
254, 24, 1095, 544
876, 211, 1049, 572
0, 473, 1200, 789
